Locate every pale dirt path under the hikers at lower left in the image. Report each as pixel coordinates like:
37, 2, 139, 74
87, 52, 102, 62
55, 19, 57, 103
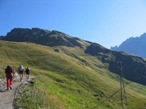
0, 76, 33, 109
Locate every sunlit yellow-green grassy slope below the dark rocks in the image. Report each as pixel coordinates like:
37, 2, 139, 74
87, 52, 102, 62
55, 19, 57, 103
0, 41, 146, 109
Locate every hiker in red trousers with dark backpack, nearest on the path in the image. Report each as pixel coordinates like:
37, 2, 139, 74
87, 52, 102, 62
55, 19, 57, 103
5, 65, 15, 90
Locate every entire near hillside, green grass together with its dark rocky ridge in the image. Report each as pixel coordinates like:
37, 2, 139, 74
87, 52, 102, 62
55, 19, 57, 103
0, 28, 146, 109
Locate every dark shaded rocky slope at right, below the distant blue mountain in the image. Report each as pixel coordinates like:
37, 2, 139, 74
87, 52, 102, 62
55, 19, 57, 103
85, 43, 146, 84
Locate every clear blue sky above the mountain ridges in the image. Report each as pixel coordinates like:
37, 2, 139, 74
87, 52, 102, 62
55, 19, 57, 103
0, 0, 146, 48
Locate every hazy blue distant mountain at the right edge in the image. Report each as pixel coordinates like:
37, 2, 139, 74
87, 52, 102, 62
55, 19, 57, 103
111, 33, 146, 58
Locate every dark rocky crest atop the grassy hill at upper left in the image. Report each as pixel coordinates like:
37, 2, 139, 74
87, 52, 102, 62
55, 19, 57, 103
3, 28, 81, 47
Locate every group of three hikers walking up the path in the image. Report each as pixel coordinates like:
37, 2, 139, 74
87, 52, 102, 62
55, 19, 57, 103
5, 65, 30, 90
